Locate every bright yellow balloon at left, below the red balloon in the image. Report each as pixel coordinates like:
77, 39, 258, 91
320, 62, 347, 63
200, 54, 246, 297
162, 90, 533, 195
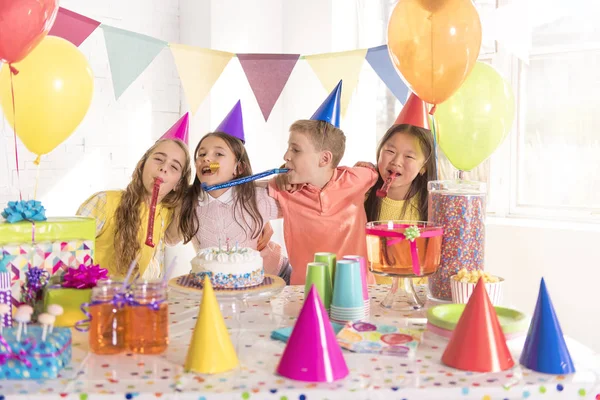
0, 36, 94, 157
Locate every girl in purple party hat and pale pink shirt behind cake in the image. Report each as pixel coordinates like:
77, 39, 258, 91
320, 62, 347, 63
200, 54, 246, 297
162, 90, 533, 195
168, 103, 291, 283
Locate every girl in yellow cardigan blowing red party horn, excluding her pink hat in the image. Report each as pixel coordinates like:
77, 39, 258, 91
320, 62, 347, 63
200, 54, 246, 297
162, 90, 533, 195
77, 139, 191, 279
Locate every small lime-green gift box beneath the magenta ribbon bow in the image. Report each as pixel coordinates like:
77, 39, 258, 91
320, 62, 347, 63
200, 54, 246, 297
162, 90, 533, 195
44, 285, 92, 327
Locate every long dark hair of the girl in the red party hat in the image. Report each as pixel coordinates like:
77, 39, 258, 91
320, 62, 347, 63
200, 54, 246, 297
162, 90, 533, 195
365, 124, 437, 221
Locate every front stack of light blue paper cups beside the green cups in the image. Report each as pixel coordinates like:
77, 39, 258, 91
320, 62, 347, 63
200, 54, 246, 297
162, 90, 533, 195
330, 260, 367, 324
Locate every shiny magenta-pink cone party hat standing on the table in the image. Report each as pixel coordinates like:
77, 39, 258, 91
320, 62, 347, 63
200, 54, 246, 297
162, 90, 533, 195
277, 285, 349, 382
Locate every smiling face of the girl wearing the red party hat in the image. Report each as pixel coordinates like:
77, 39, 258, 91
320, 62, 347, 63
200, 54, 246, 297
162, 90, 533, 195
377, 132, 425, 200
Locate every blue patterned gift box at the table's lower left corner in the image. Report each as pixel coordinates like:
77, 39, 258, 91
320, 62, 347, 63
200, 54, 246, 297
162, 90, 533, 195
0, 325, 71, 379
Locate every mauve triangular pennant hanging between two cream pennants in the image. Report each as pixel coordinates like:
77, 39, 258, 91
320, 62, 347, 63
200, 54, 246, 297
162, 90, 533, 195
237, 54, 300, 121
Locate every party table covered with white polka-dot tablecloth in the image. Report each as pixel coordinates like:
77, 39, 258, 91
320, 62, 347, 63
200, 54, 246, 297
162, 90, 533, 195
0, 286, 600, 400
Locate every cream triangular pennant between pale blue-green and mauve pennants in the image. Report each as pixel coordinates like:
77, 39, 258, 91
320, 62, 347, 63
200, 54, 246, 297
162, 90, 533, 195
169, 43, 234, 115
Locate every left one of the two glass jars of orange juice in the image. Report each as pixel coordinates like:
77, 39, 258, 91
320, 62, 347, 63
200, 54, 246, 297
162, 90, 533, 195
89, 280, 126, 354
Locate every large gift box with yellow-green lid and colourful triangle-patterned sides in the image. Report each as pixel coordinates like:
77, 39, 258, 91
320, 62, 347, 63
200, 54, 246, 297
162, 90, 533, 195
0, 217, 96, 299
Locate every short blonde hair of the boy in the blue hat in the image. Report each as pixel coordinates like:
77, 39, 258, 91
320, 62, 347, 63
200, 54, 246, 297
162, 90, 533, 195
290, 119, 346, 168
